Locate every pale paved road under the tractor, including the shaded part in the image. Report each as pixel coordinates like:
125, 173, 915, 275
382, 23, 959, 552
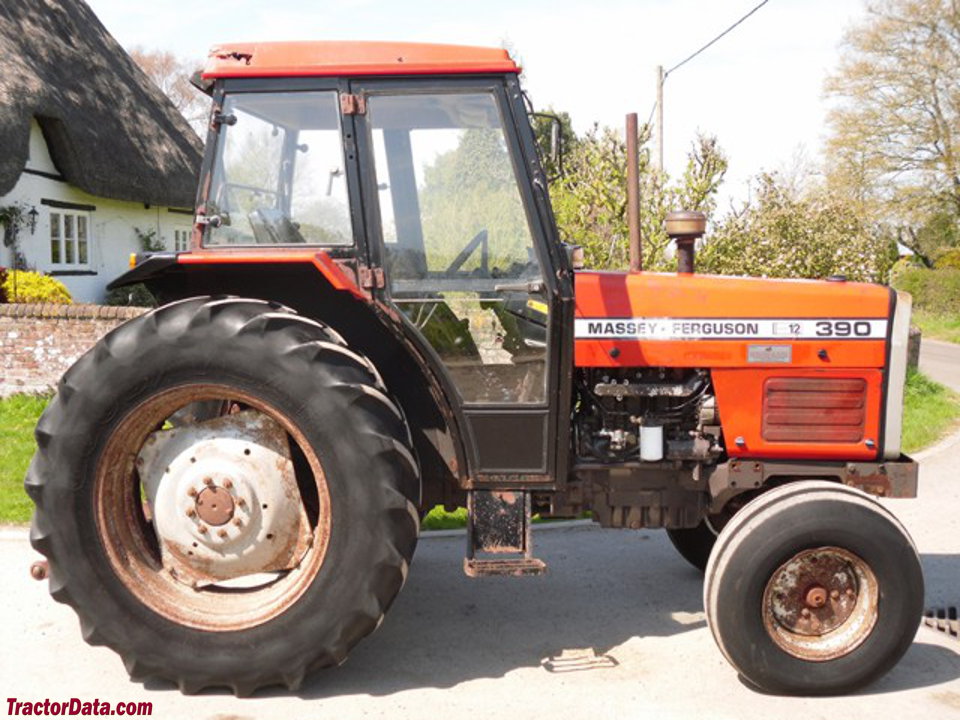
0, 434, 960, 720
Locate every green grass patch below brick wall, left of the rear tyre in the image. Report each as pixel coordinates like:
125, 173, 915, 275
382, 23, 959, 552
0, 395, 50, 523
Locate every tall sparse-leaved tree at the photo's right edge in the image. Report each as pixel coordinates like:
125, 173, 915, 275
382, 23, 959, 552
826, 0, 960, 266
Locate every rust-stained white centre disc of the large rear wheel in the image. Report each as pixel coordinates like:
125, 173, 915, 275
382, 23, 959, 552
137, 410, 311, 586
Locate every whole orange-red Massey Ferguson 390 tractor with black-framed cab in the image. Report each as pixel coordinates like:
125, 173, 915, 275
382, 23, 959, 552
26, 42, 923, 694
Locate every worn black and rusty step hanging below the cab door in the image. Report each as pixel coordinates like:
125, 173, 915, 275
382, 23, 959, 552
463, 490, 547, 577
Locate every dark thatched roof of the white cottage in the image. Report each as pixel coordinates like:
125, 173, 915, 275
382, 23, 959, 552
0, 0, 201, 207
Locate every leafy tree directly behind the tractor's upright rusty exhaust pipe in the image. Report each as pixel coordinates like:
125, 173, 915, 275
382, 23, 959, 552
550, 126, 727, 270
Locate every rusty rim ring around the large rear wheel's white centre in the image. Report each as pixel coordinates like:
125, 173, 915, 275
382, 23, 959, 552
93, 384, 331, 632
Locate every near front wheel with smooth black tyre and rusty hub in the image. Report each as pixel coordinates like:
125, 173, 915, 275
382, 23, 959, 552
704, 481, 923, 695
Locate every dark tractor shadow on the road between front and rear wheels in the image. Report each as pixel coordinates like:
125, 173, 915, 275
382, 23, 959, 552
290, 526, 706, 698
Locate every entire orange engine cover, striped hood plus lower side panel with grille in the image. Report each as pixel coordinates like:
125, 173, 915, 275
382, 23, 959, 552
574, 271, 909, 460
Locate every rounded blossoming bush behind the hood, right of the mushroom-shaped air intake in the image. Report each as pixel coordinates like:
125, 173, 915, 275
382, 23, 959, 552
697, 173, 896, 282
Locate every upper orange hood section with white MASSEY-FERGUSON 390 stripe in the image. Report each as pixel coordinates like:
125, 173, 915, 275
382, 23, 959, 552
574, 271, 895, 368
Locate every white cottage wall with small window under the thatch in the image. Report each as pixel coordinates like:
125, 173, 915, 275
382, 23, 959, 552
0, 121, 193, 302
